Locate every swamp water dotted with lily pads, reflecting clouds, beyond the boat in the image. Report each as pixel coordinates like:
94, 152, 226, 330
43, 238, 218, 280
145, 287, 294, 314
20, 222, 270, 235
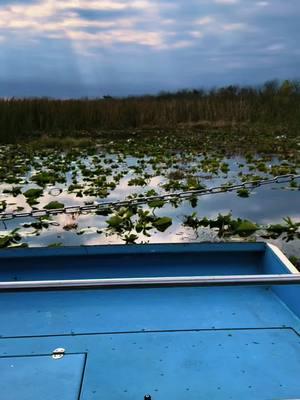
0, 146, 300, 258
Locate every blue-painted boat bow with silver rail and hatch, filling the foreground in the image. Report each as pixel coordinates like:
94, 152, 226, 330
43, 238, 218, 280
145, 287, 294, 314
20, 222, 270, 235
0, 243, 300, 400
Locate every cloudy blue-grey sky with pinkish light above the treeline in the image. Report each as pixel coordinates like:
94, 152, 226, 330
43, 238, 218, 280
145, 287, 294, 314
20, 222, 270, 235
0, 0, 300, 98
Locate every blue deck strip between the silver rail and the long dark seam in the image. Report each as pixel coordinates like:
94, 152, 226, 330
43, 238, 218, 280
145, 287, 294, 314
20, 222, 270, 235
0, 287, 299, 337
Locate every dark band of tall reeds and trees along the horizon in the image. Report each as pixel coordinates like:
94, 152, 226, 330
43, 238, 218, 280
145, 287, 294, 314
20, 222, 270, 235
0, 80, 300, 143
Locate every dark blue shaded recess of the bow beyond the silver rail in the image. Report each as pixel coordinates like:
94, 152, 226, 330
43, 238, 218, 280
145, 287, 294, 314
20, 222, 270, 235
0, 243, 265, 281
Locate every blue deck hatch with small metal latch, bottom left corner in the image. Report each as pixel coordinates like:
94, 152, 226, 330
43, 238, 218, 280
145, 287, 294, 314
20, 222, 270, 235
0, 354, 85, 400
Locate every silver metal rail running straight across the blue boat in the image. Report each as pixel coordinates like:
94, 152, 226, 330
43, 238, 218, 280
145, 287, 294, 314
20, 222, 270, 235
0, 273, 300, 292
